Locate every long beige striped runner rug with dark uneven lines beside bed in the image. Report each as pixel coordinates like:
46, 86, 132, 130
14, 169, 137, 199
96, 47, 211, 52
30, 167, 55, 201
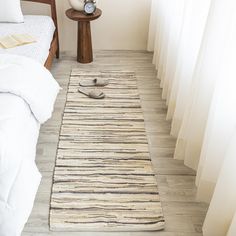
50, 69, 164, 231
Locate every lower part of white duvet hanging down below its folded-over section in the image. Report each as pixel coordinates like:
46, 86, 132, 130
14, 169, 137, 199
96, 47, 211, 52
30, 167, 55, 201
0, 93, 41, 236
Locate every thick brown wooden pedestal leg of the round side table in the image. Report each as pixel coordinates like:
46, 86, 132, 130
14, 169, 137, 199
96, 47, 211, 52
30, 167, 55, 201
77, 21, 93, 63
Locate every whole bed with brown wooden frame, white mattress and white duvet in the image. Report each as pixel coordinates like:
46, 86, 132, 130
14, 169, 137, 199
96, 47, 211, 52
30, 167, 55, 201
0, 0, 60, 236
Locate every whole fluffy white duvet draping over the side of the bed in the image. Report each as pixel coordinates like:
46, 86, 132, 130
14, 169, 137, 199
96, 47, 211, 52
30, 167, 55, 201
0, 54, 60, 236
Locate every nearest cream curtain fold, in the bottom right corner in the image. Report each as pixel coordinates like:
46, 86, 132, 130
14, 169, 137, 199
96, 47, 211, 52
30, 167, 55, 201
203, 131, 236, 236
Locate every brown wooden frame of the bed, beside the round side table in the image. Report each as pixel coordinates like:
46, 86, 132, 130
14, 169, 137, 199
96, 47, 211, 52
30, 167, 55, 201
24, 0, 60, 69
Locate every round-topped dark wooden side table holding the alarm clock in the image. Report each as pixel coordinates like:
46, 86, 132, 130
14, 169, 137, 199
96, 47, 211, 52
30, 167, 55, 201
66, 8, 102, 63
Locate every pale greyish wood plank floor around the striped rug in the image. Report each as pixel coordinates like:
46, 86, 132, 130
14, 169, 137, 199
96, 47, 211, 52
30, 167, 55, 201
22, 51, 207, 236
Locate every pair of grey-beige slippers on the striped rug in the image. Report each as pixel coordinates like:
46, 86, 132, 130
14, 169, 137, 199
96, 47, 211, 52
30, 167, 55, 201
78, 78, 109, 99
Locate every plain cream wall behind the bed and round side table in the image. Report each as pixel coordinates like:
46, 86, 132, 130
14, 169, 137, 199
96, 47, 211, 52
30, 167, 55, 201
22, 0, 151, 51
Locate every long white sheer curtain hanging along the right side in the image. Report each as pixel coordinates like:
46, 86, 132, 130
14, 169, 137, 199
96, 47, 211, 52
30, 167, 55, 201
148, 0, 236, 236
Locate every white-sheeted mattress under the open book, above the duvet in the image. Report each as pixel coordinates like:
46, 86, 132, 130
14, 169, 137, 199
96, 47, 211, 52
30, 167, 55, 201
0, 15, 55, 64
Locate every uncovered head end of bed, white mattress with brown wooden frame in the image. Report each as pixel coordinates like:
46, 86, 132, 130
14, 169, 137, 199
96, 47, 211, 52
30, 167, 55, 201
0, 0, 59, 69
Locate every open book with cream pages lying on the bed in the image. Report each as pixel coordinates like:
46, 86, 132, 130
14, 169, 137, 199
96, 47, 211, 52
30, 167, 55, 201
0, 34, 36, 49
